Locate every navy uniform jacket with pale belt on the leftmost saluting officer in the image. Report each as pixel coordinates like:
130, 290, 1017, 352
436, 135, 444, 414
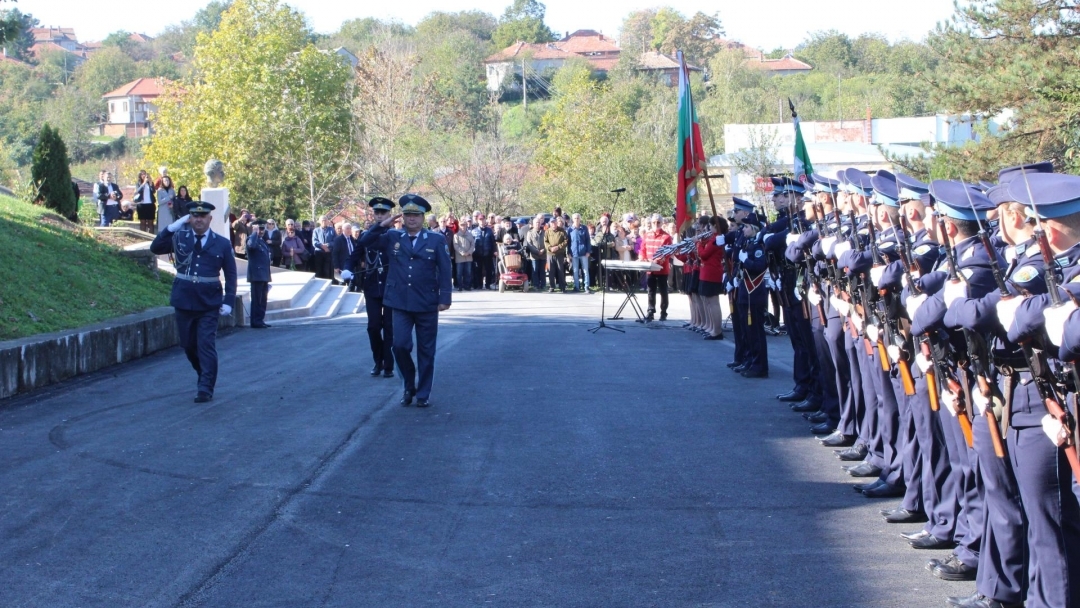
150, 227, 237, 311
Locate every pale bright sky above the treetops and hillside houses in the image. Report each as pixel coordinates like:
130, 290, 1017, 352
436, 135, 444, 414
25, 0, 954, 50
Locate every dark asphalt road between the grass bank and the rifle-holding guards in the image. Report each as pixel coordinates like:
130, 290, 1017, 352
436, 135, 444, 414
0, 293, 973, 608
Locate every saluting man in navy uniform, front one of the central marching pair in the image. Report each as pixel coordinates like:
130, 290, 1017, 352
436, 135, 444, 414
360, 194, 451, 407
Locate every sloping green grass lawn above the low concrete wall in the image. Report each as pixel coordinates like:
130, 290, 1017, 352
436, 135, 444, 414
0, 195, 172, 340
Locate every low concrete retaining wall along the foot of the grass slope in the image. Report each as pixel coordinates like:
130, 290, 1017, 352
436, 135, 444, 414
0, 297, 244, 398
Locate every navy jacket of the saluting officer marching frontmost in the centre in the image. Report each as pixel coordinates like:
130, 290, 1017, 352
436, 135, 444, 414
360, 224, 453, 312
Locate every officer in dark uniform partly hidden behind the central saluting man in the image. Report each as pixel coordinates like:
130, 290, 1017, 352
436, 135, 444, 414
341, 197, 394, 378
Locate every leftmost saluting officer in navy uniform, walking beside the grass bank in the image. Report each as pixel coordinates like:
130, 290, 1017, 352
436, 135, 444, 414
150, 201, 237, 403
